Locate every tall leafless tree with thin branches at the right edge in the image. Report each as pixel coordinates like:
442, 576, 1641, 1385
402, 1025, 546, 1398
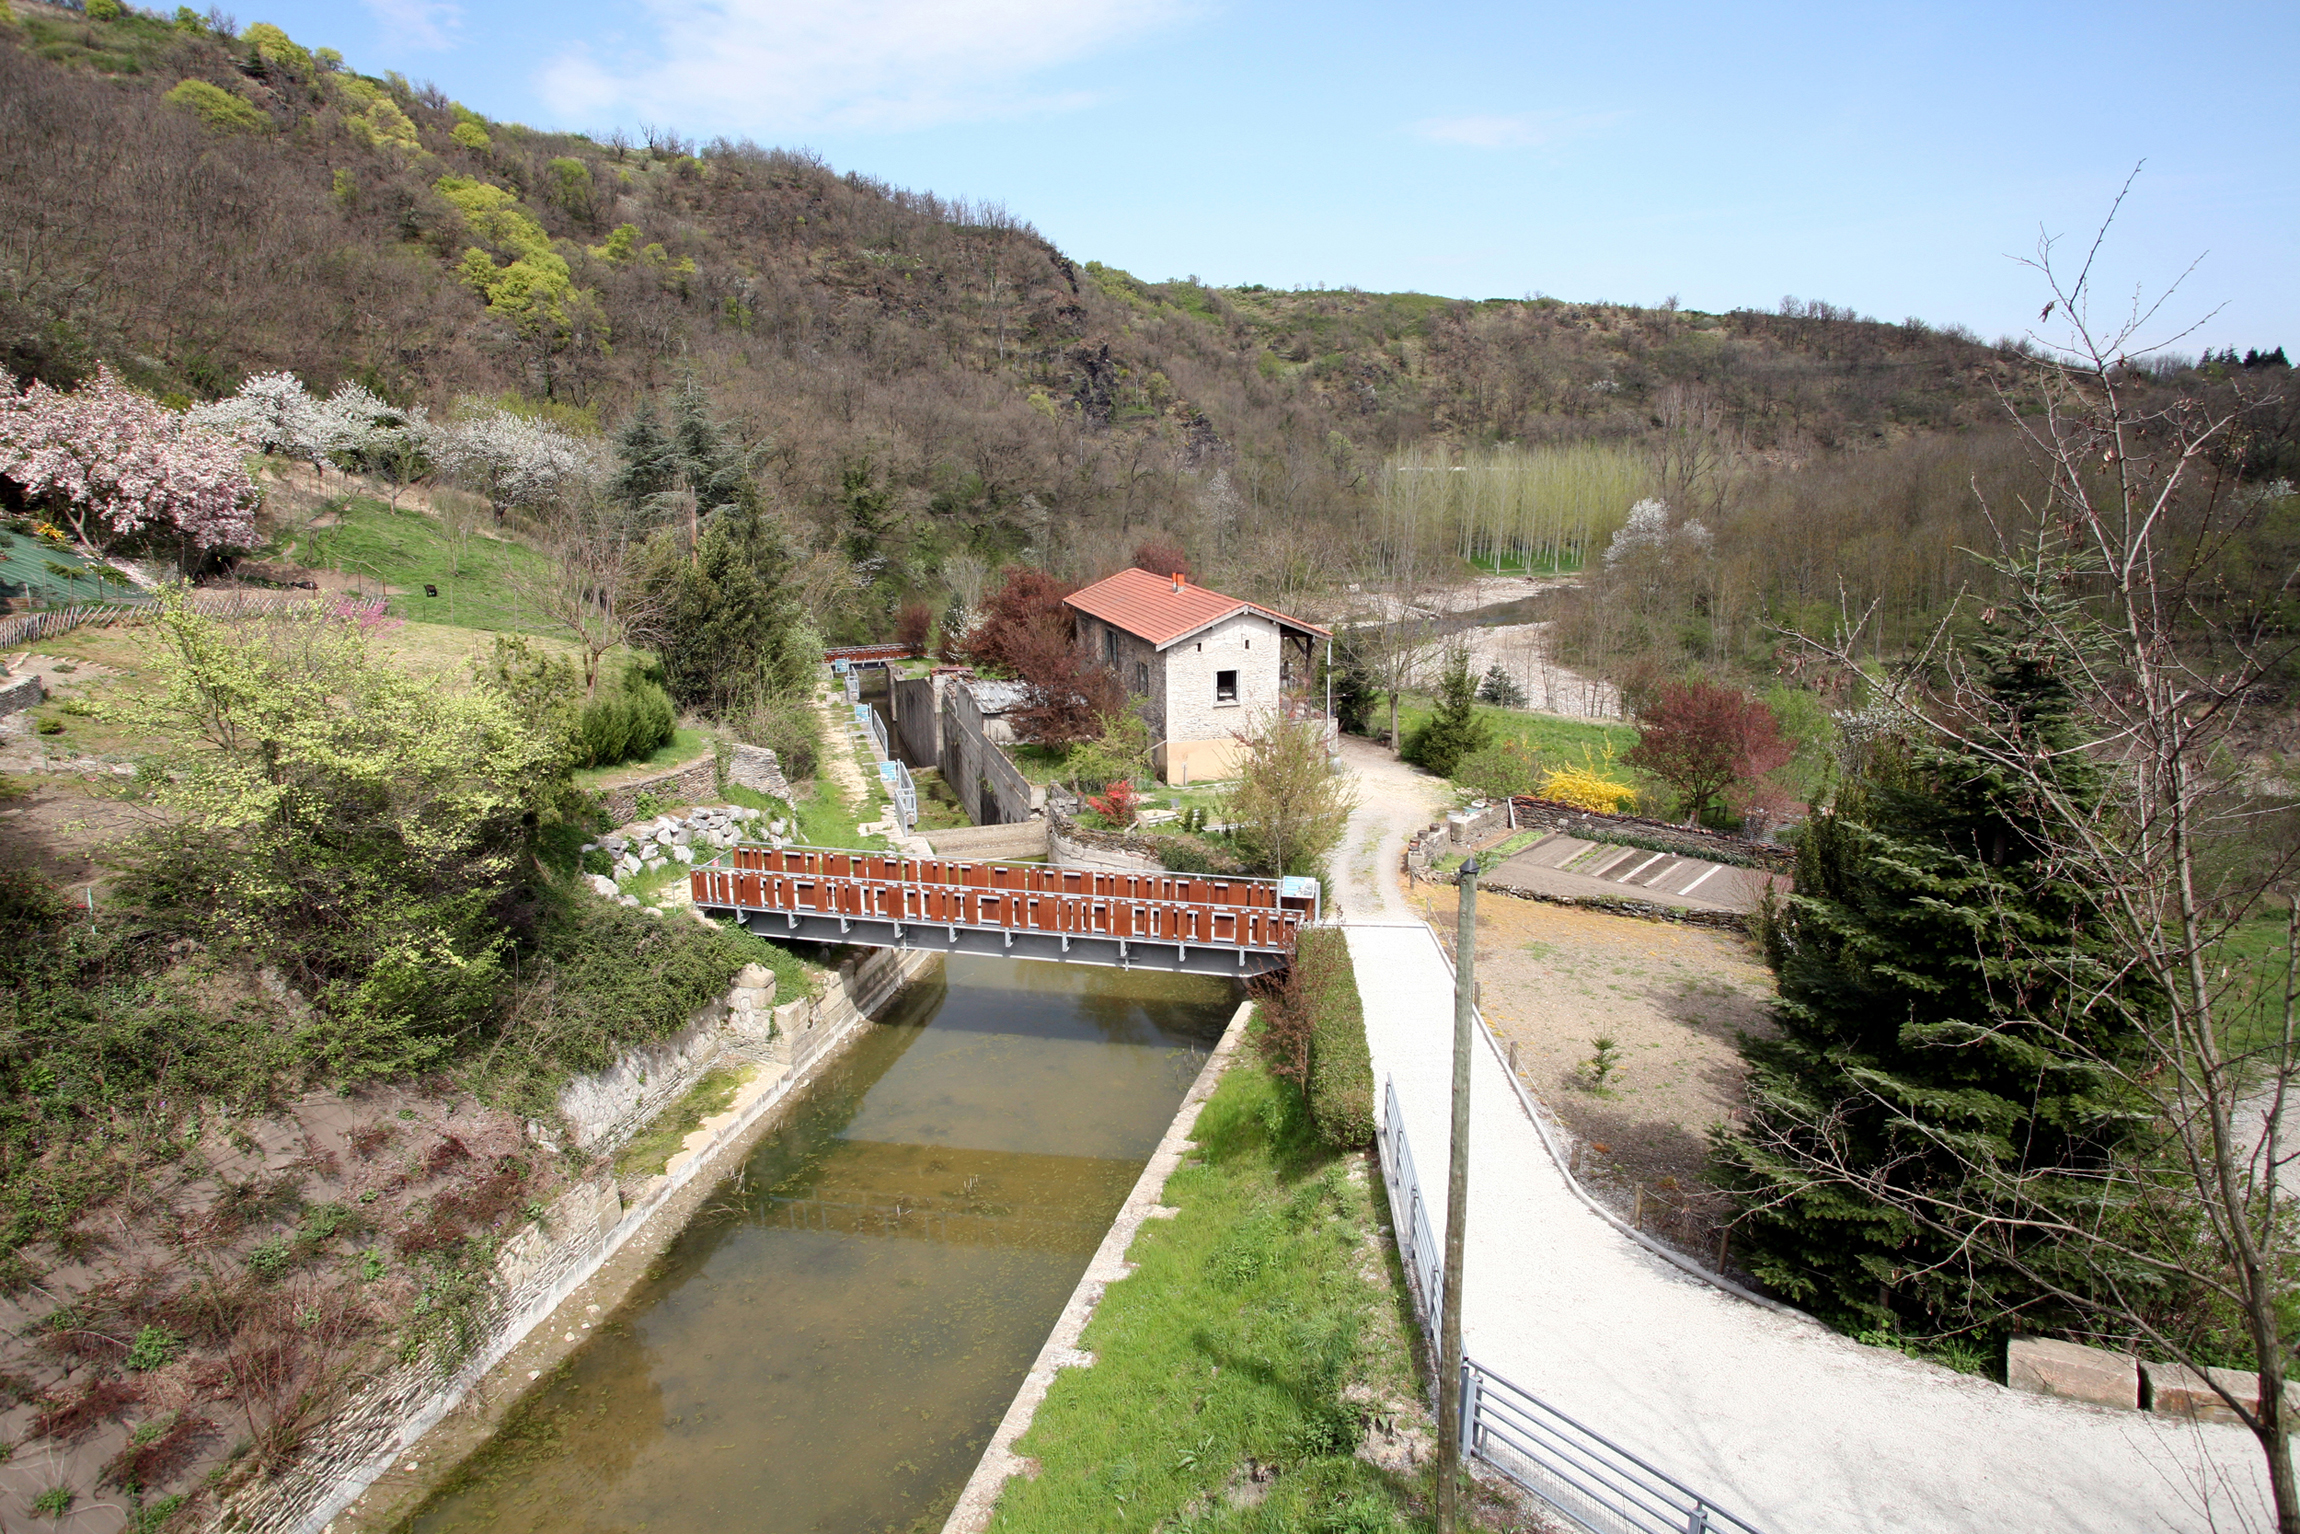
1769, 184, 2300, 1534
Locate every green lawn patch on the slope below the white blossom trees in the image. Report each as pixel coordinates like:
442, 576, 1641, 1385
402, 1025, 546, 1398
265, 497, 563, 632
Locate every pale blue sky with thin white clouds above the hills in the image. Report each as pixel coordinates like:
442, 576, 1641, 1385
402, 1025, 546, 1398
256, 0, 2300, 356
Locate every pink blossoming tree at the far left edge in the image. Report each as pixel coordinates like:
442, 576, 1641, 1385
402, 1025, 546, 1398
0, 368, 258, 568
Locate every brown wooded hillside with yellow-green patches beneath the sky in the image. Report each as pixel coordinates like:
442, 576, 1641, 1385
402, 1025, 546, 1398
0, 0, 2293, 653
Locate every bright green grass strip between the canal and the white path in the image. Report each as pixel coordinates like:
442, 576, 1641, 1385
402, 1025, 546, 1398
991, 1058, 1520, 1534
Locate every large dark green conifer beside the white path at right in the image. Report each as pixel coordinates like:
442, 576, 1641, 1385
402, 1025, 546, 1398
1711, 635, 2137, 1334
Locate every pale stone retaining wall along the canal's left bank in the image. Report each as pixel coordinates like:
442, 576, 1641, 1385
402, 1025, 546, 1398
205, 947, 941, 1534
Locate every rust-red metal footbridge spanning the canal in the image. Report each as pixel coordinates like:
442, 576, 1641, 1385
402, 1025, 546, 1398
688, 844, 1318, 975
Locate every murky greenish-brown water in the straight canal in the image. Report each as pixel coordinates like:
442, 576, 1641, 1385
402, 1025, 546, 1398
407, 957, 1237, 1534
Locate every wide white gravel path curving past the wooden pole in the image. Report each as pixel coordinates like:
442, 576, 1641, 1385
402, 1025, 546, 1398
1343, 924, 2272, 1534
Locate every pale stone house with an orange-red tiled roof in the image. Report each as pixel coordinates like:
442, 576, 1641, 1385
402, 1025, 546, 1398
1063, 570, 1332, 784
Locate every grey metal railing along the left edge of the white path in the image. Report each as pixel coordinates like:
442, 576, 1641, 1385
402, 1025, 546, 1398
1375, 1079, 1760, 1534
